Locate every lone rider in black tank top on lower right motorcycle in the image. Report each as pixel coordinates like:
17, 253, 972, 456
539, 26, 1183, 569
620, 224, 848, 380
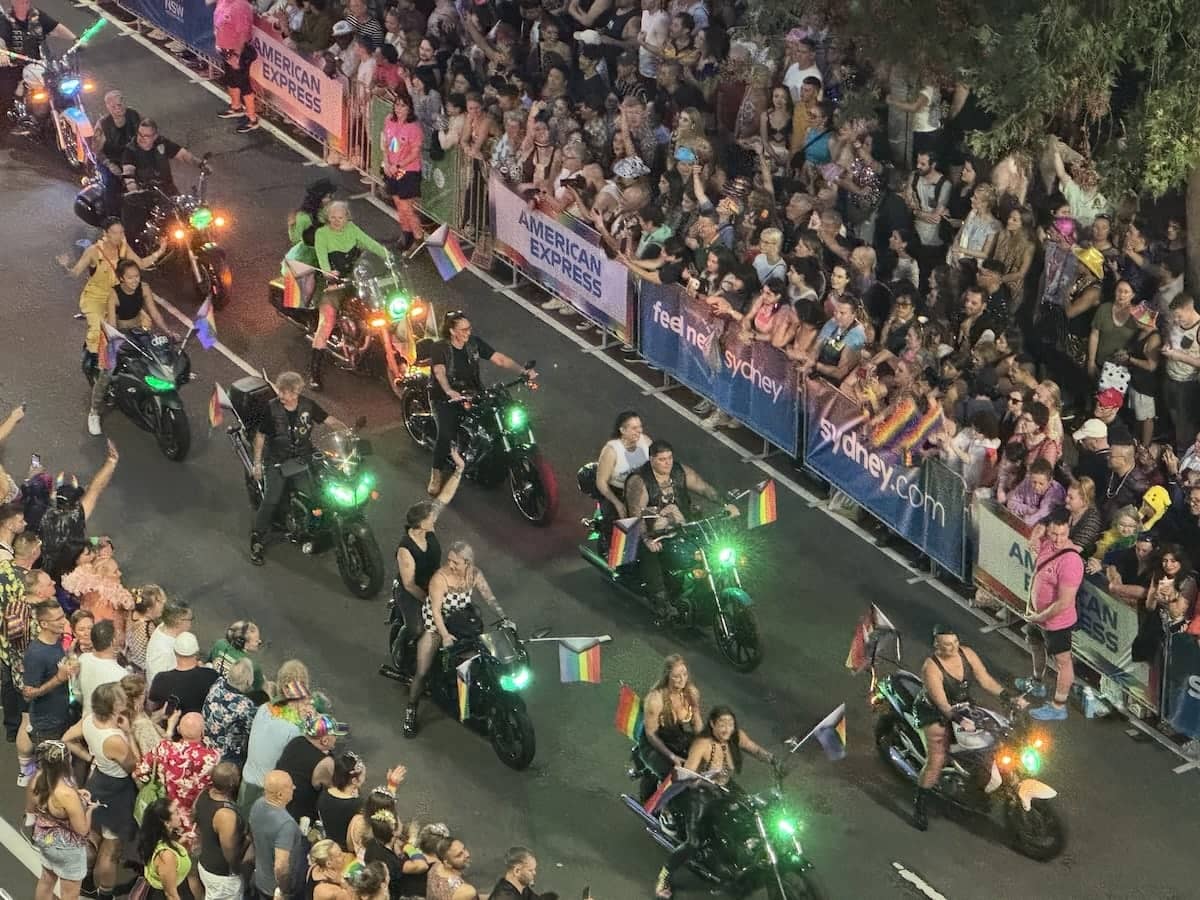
912, 625, 1028, 832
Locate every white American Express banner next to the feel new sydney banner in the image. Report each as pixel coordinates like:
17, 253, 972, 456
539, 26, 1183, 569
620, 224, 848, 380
488, 174, 631, 340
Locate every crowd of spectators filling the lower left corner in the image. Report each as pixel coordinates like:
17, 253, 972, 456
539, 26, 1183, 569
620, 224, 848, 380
0, 408, 554, 900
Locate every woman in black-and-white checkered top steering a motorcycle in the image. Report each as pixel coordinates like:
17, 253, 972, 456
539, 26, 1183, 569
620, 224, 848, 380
404, 541, 505, 738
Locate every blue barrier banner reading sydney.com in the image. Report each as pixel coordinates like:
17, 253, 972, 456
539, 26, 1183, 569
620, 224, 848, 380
804, 379, 967, 576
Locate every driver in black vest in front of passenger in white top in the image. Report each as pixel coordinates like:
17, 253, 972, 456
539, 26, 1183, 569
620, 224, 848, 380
625, 440, 740, 618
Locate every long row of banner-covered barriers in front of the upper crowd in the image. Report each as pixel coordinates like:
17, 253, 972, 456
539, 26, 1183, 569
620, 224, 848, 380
91, 0, 1200, 758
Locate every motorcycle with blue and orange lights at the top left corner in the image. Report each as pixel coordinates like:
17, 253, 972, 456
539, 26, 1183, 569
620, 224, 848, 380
8, 48, 96, 173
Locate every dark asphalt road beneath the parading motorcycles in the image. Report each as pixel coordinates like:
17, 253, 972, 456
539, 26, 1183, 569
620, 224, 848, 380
0, 8, 1196, 900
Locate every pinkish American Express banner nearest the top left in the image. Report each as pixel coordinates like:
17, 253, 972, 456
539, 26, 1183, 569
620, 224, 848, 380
250, 16, 346, 139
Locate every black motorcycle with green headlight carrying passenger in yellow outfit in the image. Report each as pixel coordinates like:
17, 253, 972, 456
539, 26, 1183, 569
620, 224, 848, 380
84, 329, 192, 462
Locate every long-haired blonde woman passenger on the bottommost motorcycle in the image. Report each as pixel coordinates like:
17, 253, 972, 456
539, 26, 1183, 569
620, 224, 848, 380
637, 653, 704, 802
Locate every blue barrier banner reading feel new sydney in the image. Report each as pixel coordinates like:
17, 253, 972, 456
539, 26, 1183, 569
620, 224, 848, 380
638, 281, 800, 454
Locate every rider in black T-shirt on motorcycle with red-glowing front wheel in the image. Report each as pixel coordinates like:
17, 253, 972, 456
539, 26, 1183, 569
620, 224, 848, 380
426, 310, 538, 497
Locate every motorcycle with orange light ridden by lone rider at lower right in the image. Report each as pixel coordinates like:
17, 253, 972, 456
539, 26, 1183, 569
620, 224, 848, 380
874, 670, 1067, 862
